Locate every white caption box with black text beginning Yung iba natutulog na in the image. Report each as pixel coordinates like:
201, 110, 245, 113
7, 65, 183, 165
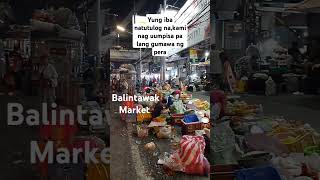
132, 14, 188, 56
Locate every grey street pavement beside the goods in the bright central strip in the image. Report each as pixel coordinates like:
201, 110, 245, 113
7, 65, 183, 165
110, 92, 209, 180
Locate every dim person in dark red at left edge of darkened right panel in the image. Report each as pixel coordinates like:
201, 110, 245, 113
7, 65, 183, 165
210, 90, 227, 121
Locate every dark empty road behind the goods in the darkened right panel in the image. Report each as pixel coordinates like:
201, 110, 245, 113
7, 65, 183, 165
241, 95, 320, 131
